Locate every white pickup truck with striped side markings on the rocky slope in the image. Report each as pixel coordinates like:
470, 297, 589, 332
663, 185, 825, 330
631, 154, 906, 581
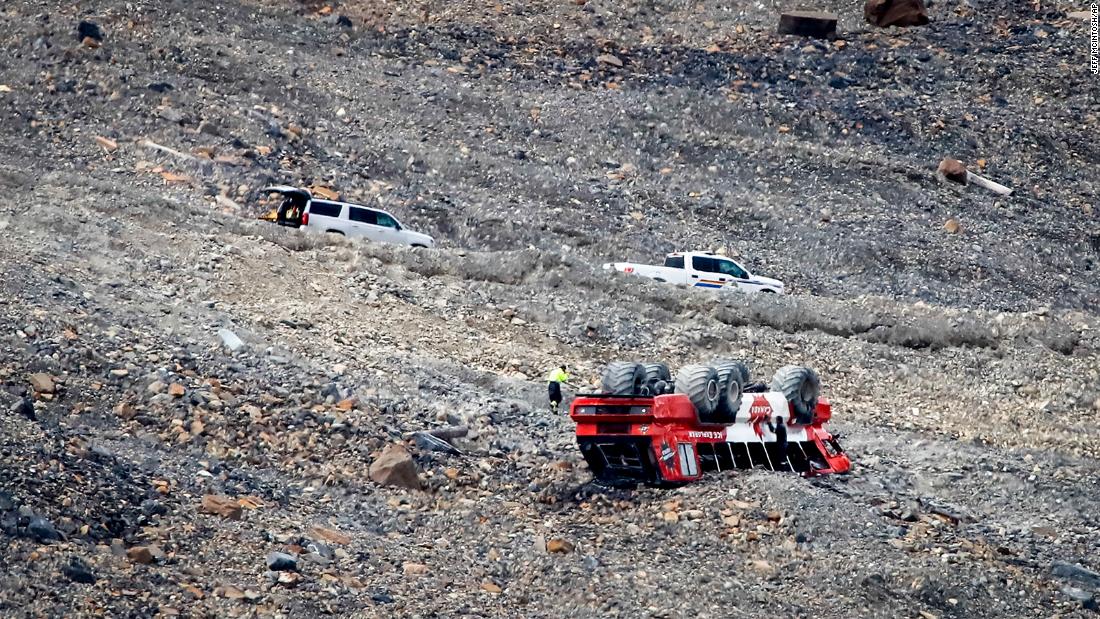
604, 252, 784, 295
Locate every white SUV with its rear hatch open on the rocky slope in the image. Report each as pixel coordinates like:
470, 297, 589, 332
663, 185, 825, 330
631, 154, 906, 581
261, 185, 436, 247
